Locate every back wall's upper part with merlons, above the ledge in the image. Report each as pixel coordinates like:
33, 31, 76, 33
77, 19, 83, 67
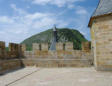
24, 42, 93, 59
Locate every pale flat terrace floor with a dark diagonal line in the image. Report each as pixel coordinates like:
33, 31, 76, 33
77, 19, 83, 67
0, 67, 112, 86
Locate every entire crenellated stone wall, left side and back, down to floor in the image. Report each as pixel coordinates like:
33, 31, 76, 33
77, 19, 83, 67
0, 42, 93, 73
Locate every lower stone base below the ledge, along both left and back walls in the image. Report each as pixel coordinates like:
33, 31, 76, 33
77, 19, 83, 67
0, 59, 93, 74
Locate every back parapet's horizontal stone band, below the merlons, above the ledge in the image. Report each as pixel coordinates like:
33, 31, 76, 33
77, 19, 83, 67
24, 50, 93, 59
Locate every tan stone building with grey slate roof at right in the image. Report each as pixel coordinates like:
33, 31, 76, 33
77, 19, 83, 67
89, 0, 112, 70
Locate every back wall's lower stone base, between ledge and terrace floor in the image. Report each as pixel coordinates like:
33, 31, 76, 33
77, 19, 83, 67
23, 59, 93, 68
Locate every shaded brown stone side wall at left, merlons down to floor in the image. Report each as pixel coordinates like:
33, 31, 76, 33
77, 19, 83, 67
0, 41, 23, 74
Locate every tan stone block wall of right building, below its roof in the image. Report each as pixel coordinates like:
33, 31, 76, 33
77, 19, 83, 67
91, 15, 112, 70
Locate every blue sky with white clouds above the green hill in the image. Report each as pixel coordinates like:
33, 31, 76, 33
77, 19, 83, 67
0, 0, 99, 43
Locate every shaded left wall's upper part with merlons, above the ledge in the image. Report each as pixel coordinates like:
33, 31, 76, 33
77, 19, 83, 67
0, 41, 22, 59
